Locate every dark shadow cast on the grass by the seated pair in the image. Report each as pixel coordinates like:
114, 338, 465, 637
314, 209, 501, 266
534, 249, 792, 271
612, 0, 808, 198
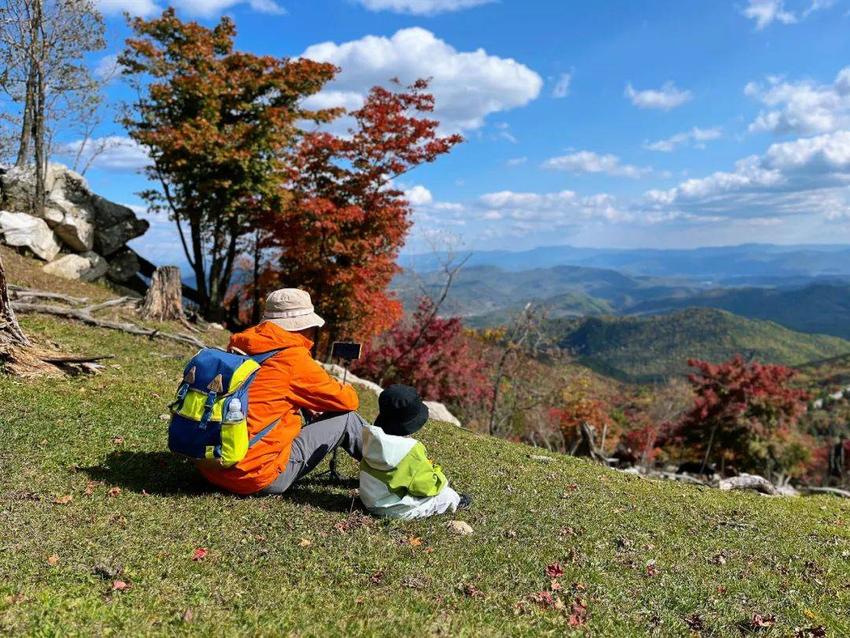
79, 450, 360, 513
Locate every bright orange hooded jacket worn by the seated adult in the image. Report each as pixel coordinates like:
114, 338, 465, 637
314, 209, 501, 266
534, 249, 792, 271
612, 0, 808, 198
200, 321, 359, 494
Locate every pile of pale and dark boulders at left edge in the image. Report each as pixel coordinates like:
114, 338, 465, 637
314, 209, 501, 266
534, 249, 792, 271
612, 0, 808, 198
0, 164, 149, 283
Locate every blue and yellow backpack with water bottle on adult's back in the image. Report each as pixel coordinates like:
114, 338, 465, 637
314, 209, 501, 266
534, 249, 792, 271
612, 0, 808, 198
168, 348, 280, 467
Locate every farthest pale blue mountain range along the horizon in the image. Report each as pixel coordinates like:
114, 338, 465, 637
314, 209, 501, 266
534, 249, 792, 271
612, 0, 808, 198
399, 244, 850, 285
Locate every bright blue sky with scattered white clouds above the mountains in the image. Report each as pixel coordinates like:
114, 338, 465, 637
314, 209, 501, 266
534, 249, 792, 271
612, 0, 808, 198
67, 0, 850, 261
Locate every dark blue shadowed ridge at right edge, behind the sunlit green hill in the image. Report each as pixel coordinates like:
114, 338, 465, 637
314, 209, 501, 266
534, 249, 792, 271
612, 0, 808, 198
628, 283, 850, 339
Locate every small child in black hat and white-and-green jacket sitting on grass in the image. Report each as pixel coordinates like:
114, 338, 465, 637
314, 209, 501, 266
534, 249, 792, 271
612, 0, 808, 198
360, 385, 471, 519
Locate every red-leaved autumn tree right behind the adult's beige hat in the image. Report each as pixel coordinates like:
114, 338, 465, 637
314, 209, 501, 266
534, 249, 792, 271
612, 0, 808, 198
266, 80, 462, 348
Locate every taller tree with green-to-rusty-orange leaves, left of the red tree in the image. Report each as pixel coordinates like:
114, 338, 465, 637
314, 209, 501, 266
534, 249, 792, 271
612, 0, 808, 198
119, 9, 339, 320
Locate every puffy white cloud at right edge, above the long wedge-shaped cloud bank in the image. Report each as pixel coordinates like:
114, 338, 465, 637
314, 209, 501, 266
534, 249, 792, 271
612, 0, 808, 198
744, 66, 850, 135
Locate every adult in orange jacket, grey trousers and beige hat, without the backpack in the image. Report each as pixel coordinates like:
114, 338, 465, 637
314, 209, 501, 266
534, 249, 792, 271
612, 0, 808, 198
199, 288, 366, 494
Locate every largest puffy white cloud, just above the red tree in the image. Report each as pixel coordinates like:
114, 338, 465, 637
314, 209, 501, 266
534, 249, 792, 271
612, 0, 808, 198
294, 27, 543, 131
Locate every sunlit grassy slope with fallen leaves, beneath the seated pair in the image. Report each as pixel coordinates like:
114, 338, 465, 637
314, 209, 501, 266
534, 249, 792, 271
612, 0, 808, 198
0, 262, 850, 637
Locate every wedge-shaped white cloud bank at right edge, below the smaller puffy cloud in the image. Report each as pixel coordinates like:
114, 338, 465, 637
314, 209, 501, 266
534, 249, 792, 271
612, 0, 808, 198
644, 131, 850, 218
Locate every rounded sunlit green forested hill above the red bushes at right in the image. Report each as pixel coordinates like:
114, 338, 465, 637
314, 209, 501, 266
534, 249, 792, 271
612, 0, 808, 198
552, 308, 850, 382
